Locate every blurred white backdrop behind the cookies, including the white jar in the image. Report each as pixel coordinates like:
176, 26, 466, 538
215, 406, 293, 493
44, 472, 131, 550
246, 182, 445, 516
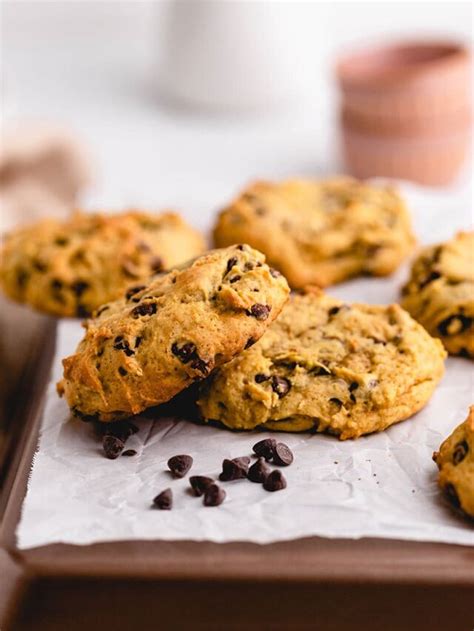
1, 0, 472, 235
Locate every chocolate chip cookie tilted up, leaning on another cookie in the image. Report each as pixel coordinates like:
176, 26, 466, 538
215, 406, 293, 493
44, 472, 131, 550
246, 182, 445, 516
58, 245, 289, 421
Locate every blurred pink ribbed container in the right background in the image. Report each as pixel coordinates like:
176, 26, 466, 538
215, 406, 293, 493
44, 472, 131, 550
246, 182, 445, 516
337, 42, 472, 185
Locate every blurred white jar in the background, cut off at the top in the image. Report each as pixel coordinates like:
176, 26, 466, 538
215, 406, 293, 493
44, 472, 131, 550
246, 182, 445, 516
158, 0, 308, 110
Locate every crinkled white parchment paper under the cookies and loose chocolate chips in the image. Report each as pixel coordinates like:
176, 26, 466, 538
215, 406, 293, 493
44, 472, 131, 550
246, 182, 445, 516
17, 187, 474, 548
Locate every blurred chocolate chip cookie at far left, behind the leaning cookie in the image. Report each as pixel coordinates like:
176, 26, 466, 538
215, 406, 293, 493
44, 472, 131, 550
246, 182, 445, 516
0, 211, 205, 317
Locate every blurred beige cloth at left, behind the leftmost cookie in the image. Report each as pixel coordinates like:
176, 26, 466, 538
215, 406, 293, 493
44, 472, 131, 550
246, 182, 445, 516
0, 124, 92, 234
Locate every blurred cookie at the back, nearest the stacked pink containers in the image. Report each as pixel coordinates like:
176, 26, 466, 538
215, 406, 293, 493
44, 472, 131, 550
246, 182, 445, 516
214, 177, 414, 288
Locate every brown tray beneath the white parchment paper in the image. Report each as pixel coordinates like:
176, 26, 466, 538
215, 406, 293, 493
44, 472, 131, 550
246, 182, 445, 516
0, 304, 474, 631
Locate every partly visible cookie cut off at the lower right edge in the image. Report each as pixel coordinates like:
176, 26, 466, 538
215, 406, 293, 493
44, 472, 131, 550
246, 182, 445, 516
433, 405, 474, 518
